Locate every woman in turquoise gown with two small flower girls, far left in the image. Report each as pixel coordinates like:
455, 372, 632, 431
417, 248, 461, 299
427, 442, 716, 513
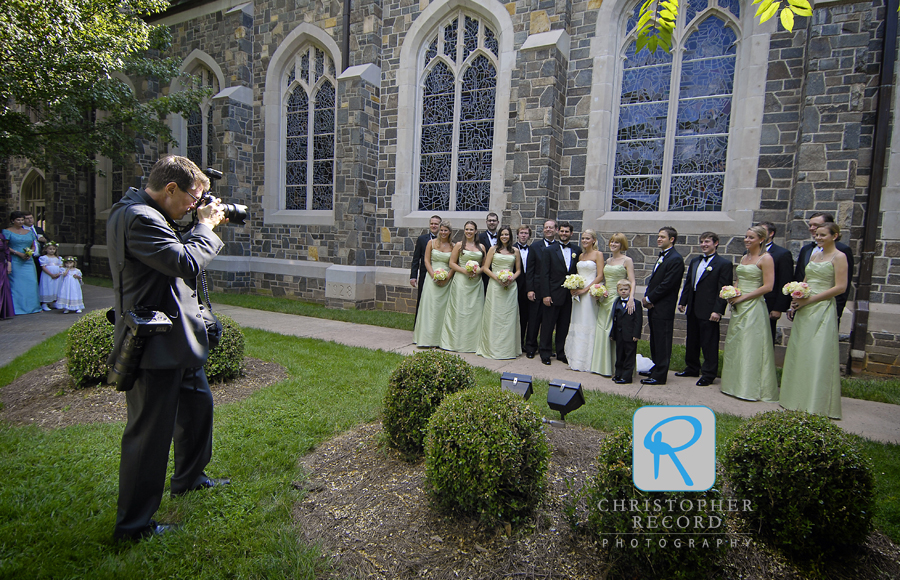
0, 211, 84, 319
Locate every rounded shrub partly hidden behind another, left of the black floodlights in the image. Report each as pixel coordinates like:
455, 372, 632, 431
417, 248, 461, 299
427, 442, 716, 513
383, 350, 475, 455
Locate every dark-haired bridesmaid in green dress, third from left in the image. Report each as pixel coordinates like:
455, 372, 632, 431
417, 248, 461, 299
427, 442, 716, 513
476, 226, 522, 359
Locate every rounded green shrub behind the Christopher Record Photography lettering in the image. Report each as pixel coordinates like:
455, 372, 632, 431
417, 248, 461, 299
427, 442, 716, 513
582, 429, 729, 579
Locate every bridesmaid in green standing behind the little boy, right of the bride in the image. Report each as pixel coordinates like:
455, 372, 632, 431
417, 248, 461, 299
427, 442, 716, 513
591, 232, 635, 377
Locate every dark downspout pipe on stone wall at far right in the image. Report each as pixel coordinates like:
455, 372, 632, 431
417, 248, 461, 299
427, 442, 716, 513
847, 0, 900, 374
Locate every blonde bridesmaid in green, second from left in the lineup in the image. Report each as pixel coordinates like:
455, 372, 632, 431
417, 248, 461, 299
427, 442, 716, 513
441, 221, 485, 352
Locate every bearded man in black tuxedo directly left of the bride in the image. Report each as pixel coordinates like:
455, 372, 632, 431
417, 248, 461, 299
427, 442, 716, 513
540, 222, 581, 365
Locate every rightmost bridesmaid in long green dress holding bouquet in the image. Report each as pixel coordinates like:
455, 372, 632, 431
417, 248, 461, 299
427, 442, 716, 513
779, 223, 847, 419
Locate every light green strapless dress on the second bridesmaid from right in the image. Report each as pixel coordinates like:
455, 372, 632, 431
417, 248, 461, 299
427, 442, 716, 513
722, 264, 778, 401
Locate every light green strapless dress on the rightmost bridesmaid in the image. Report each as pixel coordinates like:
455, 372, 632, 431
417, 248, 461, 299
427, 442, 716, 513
779, 262, 841, 419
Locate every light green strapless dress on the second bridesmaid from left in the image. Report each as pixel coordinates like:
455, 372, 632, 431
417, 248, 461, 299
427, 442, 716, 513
441, 250, 484, 352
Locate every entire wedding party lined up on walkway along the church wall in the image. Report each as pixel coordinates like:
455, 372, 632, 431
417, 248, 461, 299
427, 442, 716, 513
410, 213, 853, 419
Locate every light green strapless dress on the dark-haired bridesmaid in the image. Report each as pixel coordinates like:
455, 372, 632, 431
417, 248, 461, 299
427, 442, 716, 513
477, 253, 522, 359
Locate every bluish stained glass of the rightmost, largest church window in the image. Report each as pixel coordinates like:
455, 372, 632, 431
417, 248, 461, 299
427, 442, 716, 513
612, 0, 739, 211
